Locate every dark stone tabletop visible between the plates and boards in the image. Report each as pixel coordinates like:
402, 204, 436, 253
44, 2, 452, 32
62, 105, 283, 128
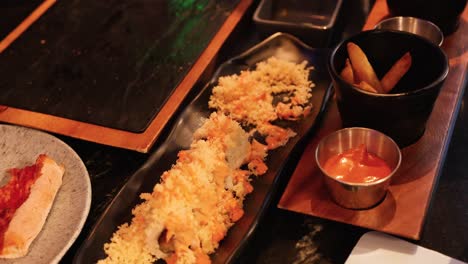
21, 0, 460, 263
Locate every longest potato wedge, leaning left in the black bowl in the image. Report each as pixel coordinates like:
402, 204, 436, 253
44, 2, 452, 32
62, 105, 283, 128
346, 42, 383, 93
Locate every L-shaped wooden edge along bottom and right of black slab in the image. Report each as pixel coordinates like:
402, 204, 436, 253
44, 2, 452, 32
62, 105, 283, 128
0, 0, 252, 152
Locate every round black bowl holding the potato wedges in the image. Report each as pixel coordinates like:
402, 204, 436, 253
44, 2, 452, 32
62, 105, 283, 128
328, 30, 449, 147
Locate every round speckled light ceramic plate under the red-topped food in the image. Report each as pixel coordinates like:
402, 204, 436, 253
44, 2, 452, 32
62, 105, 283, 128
0, 125, 91, 264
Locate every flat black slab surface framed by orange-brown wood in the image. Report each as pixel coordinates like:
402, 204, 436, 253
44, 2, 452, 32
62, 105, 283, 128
0, 0, 238, 133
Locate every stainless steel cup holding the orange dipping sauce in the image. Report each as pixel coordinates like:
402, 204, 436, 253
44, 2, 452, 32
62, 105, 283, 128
315, 127, 401, 209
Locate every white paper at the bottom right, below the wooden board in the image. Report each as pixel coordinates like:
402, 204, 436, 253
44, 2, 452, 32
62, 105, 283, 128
346, 231, 465, 264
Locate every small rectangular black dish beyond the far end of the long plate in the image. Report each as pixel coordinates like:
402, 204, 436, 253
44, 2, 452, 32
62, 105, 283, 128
253, 0, 342, 48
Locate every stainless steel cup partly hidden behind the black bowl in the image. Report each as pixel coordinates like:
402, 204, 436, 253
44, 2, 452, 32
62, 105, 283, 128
375, 16, 444, 46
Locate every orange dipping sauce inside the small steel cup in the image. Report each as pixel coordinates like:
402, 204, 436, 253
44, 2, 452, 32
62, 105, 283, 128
323, 144, 392, 183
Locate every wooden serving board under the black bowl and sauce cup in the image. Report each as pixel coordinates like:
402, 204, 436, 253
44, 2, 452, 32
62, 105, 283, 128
278, 0, 468, 240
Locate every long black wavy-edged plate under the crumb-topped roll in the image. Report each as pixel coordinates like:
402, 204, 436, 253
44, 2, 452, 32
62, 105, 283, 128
74, 33, 331, 263
